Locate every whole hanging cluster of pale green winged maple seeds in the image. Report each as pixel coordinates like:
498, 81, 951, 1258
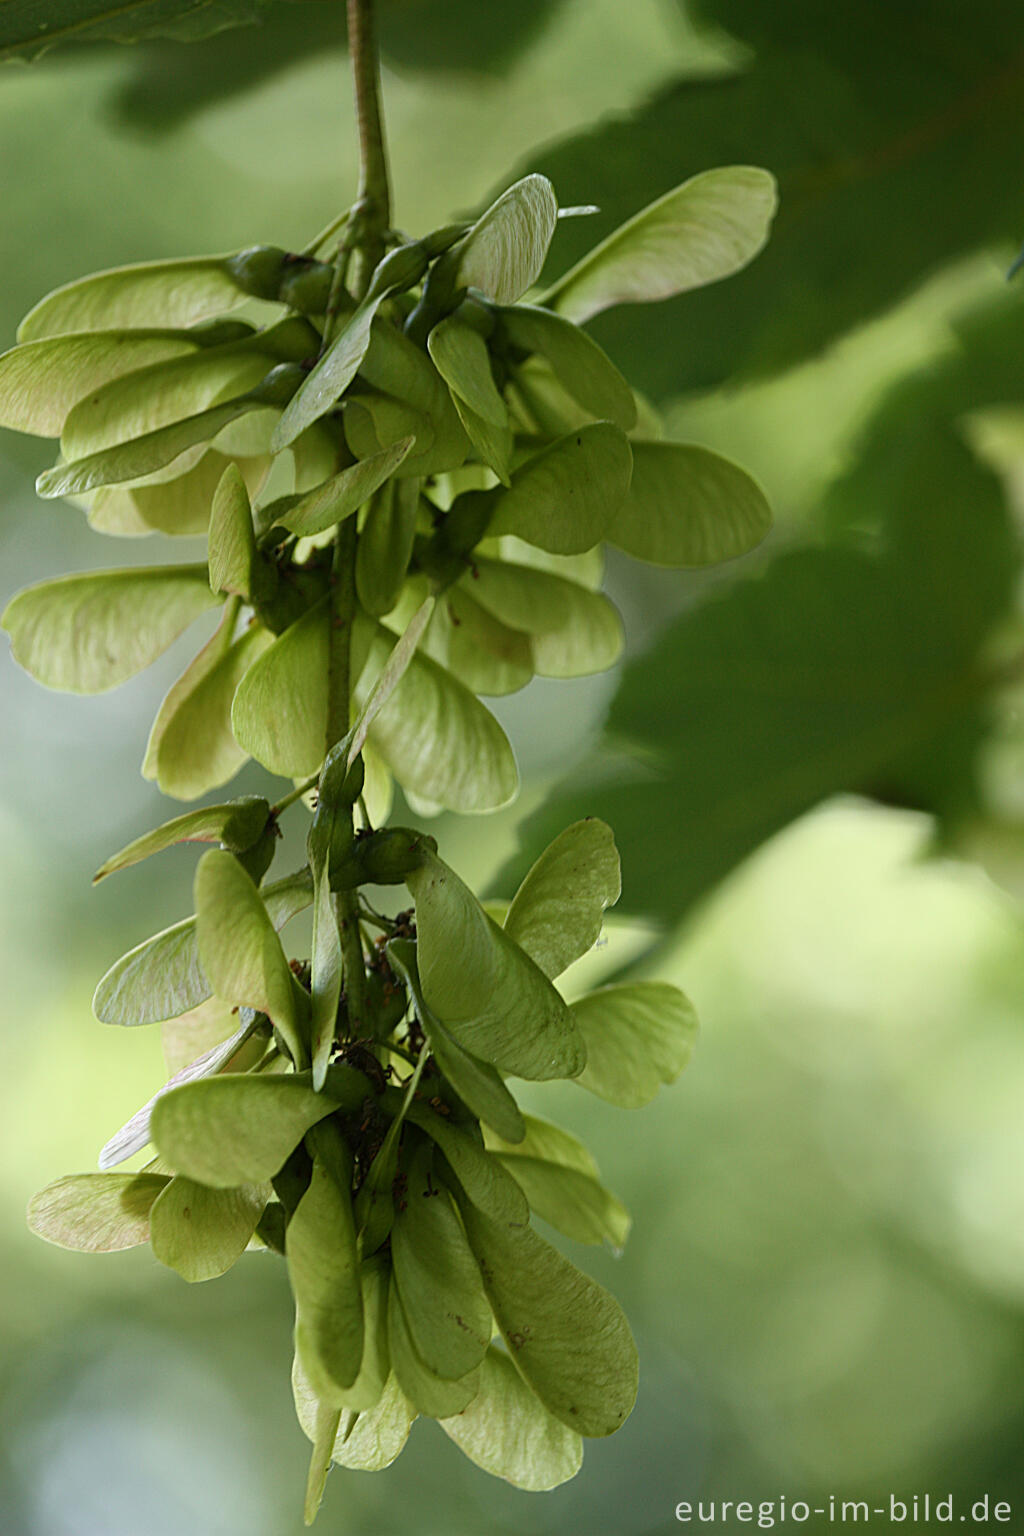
0, 167, 774, 1518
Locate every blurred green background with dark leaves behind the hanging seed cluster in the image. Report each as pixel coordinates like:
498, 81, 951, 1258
0, 0, 1024, 1536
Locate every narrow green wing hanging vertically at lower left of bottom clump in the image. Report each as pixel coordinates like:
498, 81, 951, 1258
286, 1146, 364, 1407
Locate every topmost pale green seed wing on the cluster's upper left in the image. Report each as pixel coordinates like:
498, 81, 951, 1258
18, 257, 246, 341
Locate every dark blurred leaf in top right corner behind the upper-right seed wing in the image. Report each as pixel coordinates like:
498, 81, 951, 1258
530, 0, 1024, 399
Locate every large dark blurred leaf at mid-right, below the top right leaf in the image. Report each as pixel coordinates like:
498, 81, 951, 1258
515, 365, 1019, 920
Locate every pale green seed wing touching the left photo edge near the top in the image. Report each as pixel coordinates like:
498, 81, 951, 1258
0, 329, 200, 438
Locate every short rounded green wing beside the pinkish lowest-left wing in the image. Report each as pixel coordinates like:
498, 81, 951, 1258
149, 1174, 270, 1281
